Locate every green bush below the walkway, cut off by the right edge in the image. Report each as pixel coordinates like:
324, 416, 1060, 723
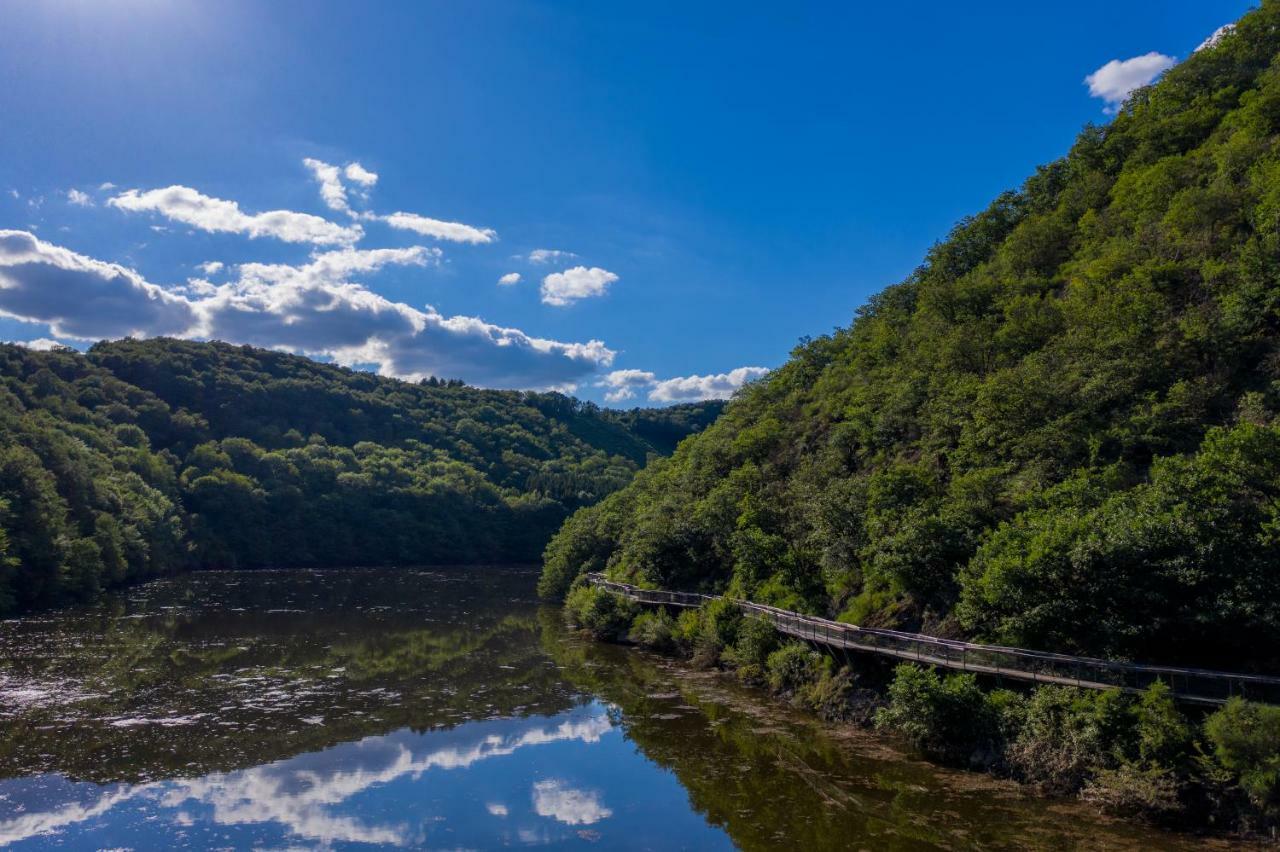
1204, 698, 1280, 816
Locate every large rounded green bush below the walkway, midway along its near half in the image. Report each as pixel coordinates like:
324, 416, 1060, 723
876, 663, 1007, 765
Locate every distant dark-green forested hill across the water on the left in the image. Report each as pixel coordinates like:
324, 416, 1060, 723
0, 339, 721, 615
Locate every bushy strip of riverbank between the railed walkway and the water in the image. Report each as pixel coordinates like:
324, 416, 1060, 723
564, 586, 1280, 840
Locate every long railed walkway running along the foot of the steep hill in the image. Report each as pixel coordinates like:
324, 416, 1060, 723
586, 573, 1280, 704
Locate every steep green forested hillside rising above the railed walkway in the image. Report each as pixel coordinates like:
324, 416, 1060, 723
543, 0, 1280, 669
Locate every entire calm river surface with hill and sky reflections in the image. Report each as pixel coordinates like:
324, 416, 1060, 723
0, 568, 1218, 849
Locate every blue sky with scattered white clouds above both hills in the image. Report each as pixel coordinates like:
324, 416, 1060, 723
0, 0, 1252, 407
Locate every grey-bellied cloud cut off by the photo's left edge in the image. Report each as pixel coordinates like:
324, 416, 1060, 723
0, 230, 196, 340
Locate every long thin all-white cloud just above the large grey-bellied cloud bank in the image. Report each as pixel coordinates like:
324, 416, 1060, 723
106, 187, 365, 246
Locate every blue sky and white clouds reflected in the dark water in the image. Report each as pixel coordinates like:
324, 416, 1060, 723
0, 701, 731, 848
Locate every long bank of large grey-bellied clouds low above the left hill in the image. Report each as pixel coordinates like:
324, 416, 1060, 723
0, 232, 614, 388
